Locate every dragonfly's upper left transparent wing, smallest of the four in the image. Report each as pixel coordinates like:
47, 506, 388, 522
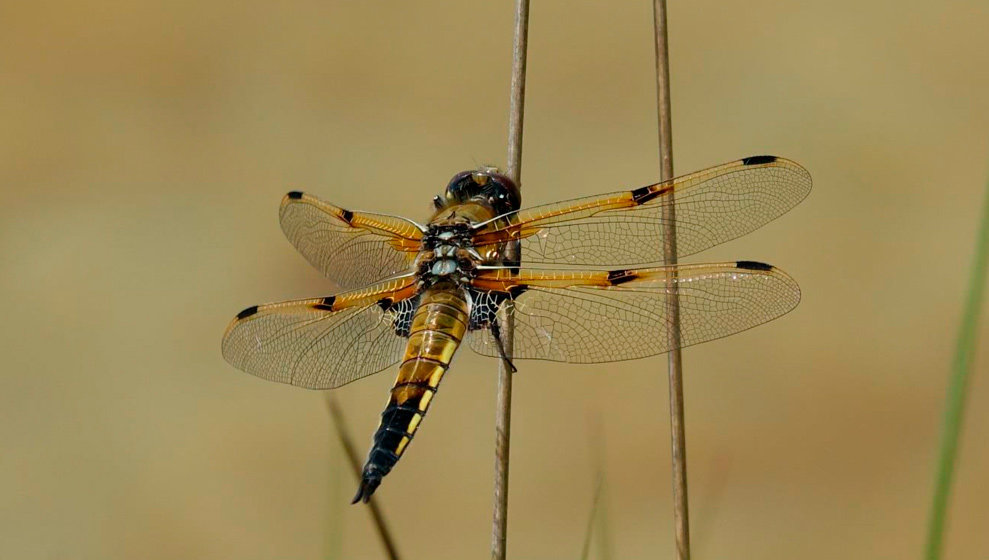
279, 191, 422, 289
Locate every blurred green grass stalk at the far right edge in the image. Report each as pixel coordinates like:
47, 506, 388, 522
924, 173, 989, 560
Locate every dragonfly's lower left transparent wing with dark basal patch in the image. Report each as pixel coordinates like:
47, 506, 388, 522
223, 275, 416, 389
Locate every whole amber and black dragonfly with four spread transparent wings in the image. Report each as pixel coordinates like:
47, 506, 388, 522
222, 156, 811, 503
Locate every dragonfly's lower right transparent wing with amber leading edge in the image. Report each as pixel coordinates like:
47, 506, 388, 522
468, 261, 800, 363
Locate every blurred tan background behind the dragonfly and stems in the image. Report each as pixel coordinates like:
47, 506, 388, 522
0, 0, 989, 559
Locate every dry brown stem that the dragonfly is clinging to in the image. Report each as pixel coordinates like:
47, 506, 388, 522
491, 0, 529, 560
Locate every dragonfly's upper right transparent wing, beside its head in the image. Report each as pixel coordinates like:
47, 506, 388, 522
474, 156, 811, 266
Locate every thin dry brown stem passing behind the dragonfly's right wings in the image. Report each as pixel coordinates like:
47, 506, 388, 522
653, 0, 690, 560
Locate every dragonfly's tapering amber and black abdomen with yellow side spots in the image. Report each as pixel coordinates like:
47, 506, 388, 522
354, 285, 469, 503
